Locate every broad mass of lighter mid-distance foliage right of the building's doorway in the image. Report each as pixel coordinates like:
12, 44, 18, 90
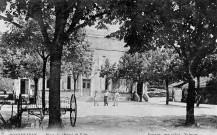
115, 48, 184, 84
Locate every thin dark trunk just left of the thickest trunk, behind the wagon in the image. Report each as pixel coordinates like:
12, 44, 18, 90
42, 58, 47, 114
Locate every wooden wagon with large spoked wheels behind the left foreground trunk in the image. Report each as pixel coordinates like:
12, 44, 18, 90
0, 91, 77, 127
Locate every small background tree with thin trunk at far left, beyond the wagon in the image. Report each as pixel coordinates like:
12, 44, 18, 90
1, 48, 43, 100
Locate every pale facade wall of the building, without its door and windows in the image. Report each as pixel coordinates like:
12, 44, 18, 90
13, 27, 128, 96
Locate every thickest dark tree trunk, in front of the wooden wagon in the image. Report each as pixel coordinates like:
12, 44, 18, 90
48, 45, 63, 128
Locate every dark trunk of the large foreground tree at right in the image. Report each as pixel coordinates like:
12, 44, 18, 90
186, 77, 195, 126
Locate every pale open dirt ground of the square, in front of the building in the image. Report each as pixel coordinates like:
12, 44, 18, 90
1, 99, 217, 135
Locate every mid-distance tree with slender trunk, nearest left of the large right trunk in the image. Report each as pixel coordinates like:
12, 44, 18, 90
147, 48, 182, 105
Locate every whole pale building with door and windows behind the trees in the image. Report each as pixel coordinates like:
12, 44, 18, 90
14, 27, 128, 96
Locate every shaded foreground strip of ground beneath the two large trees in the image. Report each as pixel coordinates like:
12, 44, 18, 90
1, 115, 217, 135
